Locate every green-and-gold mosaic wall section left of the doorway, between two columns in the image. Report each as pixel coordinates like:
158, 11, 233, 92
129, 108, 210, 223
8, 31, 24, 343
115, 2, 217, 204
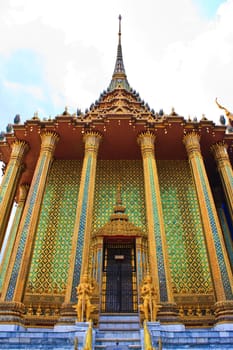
27, 160, 82, 294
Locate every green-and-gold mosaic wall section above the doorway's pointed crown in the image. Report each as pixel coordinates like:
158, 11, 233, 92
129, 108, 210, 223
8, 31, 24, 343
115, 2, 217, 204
93, 160, 146, 232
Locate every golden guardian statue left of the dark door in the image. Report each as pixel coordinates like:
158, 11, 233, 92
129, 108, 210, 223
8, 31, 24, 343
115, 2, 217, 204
74, 274, 95, 322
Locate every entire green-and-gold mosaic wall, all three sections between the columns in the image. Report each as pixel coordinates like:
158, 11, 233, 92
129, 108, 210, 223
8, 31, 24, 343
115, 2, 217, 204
27, 160, 212, 294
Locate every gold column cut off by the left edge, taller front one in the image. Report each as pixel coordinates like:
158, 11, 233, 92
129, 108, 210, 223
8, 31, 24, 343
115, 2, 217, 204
0, 141, 29, 250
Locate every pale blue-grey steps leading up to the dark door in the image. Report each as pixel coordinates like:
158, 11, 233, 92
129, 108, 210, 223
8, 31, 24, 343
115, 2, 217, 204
94, 314, 141, 350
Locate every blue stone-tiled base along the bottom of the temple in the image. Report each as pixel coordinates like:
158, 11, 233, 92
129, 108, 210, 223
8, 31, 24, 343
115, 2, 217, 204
0, 322, 233, 350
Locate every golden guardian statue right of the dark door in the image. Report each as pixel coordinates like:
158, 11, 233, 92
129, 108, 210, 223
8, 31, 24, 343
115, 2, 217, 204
140, 274, 161, 321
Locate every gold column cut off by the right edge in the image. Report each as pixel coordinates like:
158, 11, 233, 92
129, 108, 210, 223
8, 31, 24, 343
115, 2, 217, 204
211, 142, 233, 222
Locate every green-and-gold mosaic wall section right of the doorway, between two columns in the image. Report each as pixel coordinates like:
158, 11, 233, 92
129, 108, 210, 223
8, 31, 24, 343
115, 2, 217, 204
157, 160, 212, 294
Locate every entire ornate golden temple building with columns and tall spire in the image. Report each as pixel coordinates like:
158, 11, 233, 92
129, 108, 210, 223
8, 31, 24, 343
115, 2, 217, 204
0, 15, 233, 349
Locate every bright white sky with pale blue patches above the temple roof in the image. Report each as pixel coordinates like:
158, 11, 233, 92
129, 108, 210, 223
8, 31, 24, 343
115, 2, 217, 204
0, 0, 233, 130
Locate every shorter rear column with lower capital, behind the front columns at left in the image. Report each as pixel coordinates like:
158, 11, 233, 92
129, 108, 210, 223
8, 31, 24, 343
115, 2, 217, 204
0, 184, 29, 291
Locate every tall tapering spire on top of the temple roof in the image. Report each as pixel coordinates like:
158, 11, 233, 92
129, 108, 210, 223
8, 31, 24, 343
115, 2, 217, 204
109, 15, 130, 91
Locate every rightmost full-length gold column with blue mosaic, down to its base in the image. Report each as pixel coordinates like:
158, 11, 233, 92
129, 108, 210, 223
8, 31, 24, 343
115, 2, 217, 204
183, 132, 233, 318
